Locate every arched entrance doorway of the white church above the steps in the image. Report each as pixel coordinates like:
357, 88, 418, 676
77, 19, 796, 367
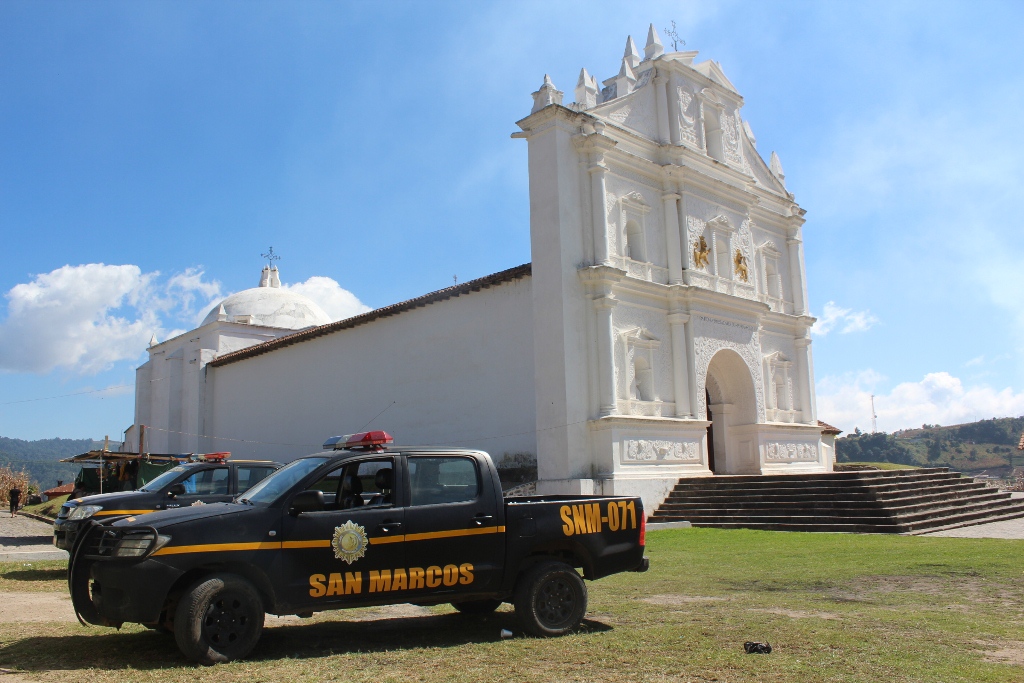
705, 349, 761, 474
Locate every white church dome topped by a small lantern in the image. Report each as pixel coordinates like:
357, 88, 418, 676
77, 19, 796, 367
203, 266, 331, 330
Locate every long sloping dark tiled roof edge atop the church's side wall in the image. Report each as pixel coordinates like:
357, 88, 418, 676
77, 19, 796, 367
207, 263, 531, 368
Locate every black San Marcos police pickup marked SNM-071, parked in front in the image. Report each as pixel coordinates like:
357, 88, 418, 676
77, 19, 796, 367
68, 431, 647, 665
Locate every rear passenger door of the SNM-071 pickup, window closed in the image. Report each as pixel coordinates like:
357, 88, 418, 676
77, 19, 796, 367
406, 455, 505, 597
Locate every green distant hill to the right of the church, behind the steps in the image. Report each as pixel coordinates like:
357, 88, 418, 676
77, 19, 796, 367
836, 417, 1024, 474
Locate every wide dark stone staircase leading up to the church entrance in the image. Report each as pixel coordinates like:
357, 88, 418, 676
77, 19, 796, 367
649, 467, 1024, 533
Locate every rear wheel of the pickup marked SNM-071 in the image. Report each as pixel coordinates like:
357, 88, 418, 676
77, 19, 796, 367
514, 562, 587, 638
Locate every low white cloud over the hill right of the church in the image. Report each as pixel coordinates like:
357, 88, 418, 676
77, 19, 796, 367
817, 370, 1024, 432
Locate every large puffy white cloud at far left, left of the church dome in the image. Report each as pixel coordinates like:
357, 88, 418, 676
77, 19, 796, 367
0, 263, 220, 375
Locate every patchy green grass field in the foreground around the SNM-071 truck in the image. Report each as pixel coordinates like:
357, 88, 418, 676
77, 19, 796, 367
0, 528, 1024, 683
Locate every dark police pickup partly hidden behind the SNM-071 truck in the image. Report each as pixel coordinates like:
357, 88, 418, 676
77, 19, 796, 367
53, 453, 281, 550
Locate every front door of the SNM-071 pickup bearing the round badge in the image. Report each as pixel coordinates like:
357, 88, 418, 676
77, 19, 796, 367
278, 456, 406, 611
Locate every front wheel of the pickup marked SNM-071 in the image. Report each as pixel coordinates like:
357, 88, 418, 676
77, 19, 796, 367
174, 573, 264, 667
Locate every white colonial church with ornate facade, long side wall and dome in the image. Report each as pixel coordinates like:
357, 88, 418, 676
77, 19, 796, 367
128, 27, 834, 510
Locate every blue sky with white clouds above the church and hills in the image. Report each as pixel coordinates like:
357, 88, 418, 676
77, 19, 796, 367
0, 0, 1024, 438
